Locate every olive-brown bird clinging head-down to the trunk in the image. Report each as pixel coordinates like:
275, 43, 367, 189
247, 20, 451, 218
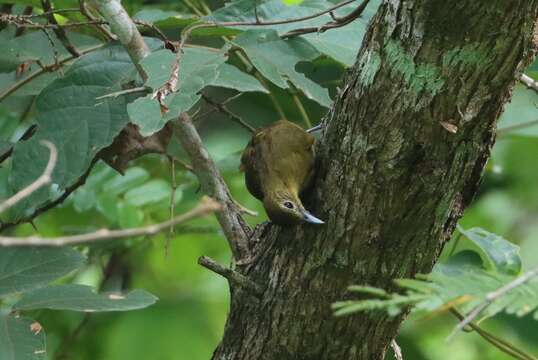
240, 120, 324, 226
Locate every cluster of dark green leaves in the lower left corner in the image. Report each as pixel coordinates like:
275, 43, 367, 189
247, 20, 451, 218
0, 247, 156, 359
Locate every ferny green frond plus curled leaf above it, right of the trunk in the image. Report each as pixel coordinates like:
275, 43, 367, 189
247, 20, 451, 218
333, 228, 538, 320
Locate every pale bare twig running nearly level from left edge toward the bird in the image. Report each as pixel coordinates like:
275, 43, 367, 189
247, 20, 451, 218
0, 197, 221, 247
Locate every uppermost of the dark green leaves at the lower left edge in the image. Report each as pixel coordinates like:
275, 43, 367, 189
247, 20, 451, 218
0, 247, 85, 297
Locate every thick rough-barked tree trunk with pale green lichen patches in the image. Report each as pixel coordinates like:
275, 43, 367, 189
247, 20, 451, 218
213, 0, 538, 360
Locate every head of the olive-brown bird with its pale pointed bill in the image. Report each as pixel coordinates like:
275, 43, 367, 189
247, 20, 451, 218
263, 191, 324, 225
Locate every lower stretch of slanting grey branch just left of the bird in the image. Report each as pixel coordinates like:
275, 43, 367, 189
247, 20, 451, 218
174, 113, 250, 260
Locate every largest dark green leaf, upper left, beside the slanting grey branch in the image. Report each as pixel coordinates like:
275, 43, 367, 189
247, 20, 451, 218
10, 44, 135, 217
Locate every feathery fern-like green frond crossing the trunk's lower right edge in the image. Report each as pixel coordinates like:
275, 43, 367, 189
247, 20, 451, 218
333, 253, 538, 320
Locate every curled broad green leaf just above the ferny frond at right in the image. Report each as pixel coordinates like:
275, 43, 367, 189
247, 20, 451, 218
452, 227, 521, 275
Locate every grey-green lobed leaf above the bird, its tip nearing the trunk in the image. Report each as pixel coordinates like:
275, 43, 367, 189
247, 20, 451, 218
234, 30, 332, 107
